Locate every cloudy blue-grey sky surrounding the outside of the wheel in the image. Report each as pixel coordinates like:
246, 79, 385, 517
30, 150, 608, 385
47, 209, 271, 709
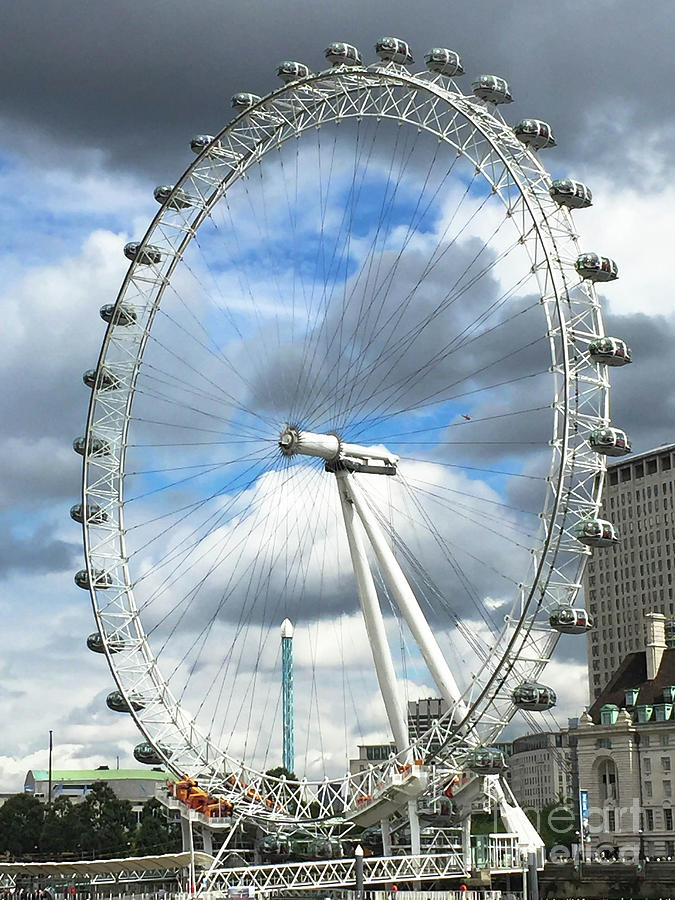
0, 0, 675, 790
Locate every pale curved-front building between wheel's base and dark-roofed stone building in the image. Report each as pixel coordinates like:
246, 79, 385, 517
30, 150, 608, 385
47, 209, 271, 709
507, 729, 576, 810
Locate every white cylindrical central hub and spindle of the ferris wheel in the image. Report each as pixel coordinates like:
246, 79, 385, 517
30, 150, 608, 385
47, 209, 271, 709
279, 425, 398, 475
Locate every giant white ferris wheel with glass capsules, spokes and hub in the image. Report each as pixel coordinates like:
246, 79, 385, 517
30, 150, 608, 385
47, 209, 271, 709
71, 38, 630, 823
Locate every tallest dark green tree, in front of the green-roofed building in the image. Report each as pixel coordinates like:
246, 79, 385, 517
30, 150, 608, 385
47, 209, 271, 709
75, 781, 136, 856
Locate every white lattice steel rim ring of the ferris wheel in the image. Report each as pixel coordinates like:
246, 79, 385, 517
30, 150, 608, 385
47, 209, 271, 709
82, 64, 609, 828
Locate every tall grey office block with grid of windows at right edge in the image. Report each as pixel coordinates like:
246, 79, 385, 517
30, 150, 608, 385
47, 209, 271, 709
584, 444, 675, 702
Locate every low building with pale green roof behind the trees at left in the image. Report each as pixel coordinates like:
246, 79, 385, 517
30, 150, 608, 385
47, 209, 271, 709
23, 766, 168, 812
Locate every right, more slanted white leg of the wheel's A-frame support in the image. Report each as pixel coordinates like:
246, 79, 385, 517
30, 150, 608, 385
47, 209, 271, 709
341, 473, 467, 718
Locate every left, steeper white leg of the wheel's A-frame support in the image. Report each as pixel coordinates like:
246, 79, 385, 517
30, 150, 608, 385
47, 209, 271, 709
336, 472, 410, 752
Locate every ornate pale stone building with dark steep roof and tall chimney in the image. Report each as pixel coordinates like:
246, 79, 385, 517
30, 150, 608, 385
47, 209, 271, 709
576, 613, 675, 858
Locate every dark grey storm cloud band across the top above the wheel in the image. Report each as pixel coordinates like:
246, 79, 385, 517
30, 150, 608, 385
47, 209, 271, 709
0, 0, 675, 180
